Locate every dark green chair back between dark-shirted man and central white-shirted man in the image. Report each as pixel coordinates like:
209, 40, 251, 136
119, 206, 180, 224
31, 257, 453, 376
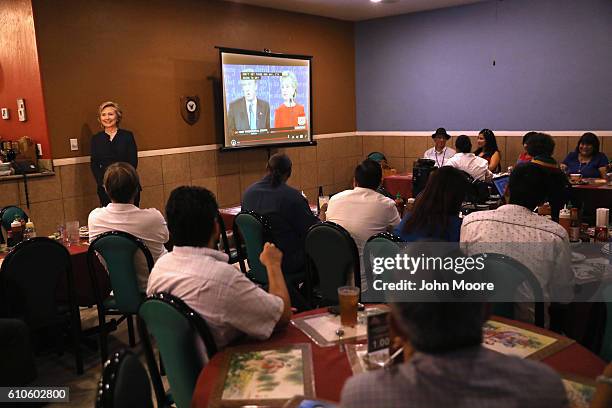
305, 221, 361, 306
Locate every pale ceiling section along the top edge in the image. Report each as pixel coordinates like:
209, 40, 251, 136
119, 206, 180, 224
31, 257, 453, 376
226, 0, 490, 21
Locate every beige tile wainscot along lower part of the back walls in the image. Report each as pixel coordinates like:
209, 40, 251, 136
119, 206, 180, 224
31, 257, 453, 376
0, 135, 612, 235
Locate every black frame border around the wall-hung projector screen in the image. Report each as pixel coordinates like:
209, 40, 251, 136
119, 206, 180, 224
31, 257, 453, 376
215, 46, 317, 152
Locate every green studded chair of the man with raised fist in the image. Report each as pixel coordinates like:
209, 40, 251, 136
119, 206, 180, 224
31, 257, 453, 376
138, 292, 217, 408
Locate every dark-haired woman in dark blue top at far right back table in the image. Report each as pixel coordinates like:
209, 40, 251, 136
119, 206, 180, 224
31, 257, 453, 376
561, 132, 608, 178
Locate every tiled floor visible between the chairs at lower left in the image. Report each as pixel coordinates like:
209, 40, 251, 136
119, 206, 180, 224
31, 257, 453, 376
30, 307, 168, 408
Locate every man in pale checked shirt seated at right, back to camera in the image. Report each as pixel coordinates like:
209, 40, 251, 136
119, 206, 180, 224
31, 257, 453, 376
461, 163, 574, 322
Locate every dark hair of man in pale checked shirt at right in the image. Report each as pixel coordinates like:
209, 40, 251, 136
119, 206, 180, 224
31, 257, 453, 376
508, 163, 549, 210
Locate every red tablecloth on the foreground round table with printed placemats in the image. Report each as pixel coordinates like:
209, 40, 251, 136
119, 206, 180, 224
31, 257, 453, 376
192, 309, 605, 407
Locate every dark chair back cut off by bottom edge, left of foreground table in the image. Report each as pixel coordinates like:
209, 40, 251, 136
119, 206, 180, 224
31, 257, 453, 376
95, 349, 153, 408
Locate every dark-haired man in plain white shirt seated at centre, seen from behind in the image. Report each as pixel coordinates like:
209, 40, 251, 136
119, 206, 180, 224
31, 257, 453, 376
321, 159, 401, 291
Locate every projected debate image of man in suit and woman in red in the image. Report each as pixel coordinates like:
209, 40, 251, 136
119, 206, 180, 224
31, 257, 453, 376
221, 52, 311, 148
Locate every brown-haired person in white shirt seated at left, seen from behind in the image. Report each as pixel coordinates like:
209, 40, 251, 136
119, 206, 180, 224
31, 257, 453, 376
87, 162, 168, 292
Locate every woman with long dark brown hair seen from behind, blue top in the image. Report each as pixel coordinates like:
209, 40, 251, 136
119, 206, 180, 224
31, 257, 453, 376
394, 166, 468, 242
